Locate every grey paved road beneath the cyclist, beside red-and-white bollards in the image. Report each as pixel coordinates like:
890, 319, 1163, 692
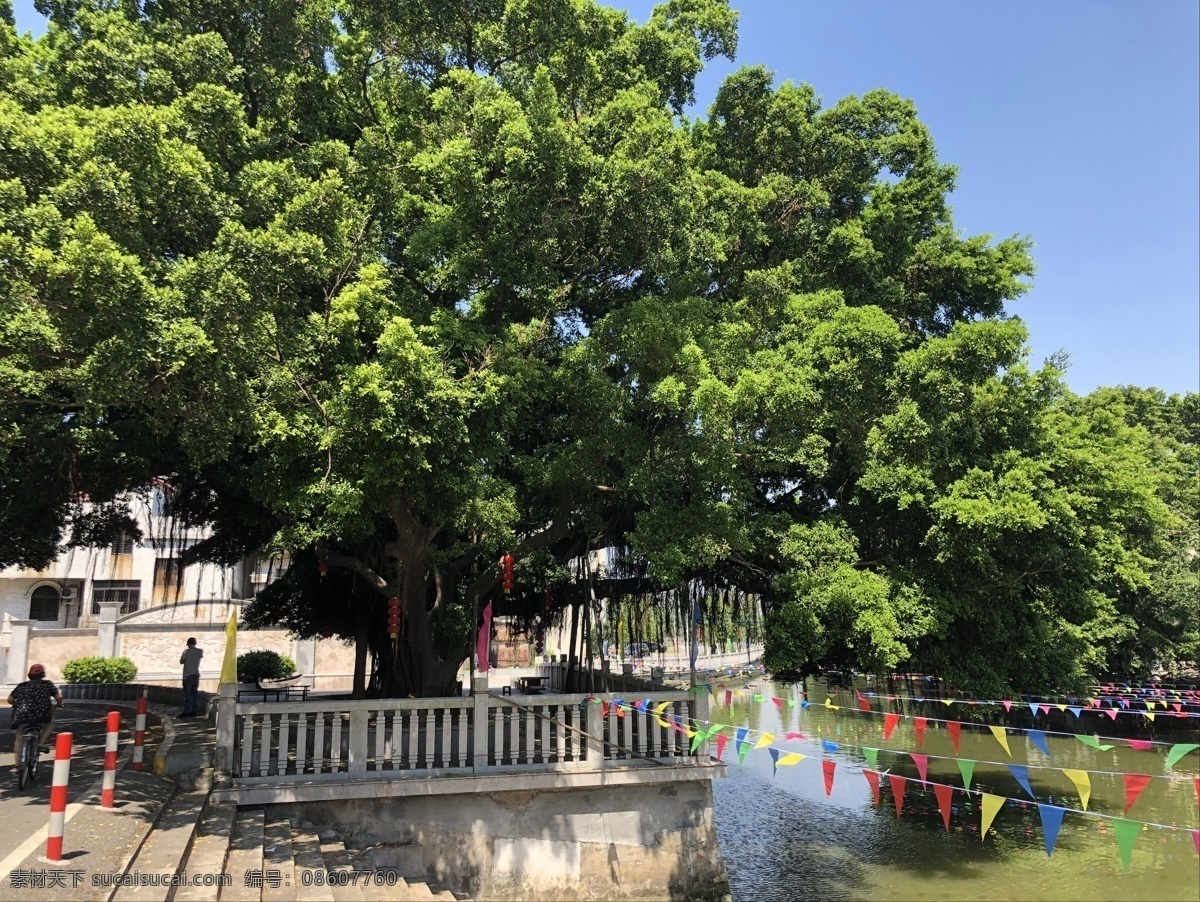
0, 702, 141, 860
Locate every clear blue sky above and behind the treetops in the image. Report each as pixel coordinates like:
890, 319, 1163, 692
9, 0, 1200, 392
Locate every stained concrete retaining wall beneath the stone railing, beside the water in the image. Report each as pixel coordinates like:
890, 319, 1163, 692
278, 776, 728, 900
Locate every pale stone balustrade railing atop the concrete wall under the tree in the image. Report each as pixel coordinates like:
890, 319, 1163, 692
216, 680, 708, 784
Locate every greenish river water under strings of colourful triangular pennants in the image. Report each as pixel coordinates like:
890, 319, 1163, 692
710, 678, 1200, 902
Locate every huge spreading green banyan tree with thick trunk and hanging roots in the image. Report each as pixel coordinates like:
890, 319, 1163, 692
0, 0, 1188, 696
